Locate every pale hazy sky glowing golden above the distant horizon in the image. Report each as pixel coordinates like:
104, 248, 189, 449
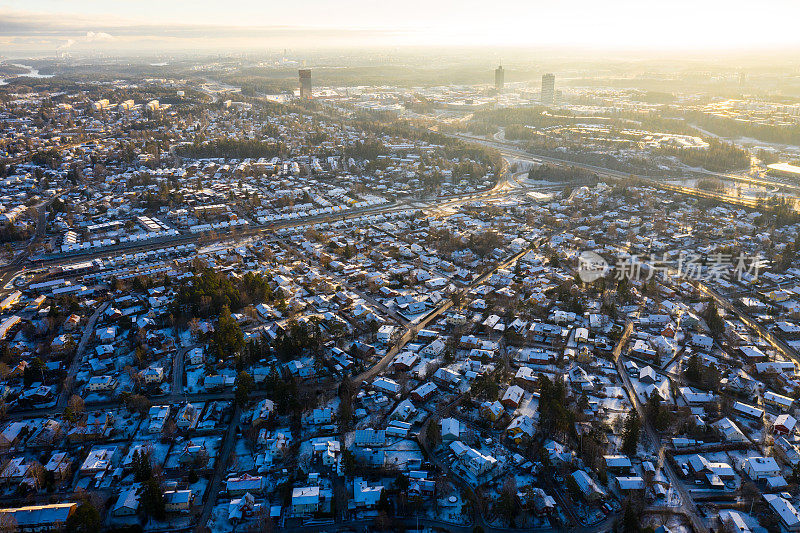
0, 0, 800, 54
